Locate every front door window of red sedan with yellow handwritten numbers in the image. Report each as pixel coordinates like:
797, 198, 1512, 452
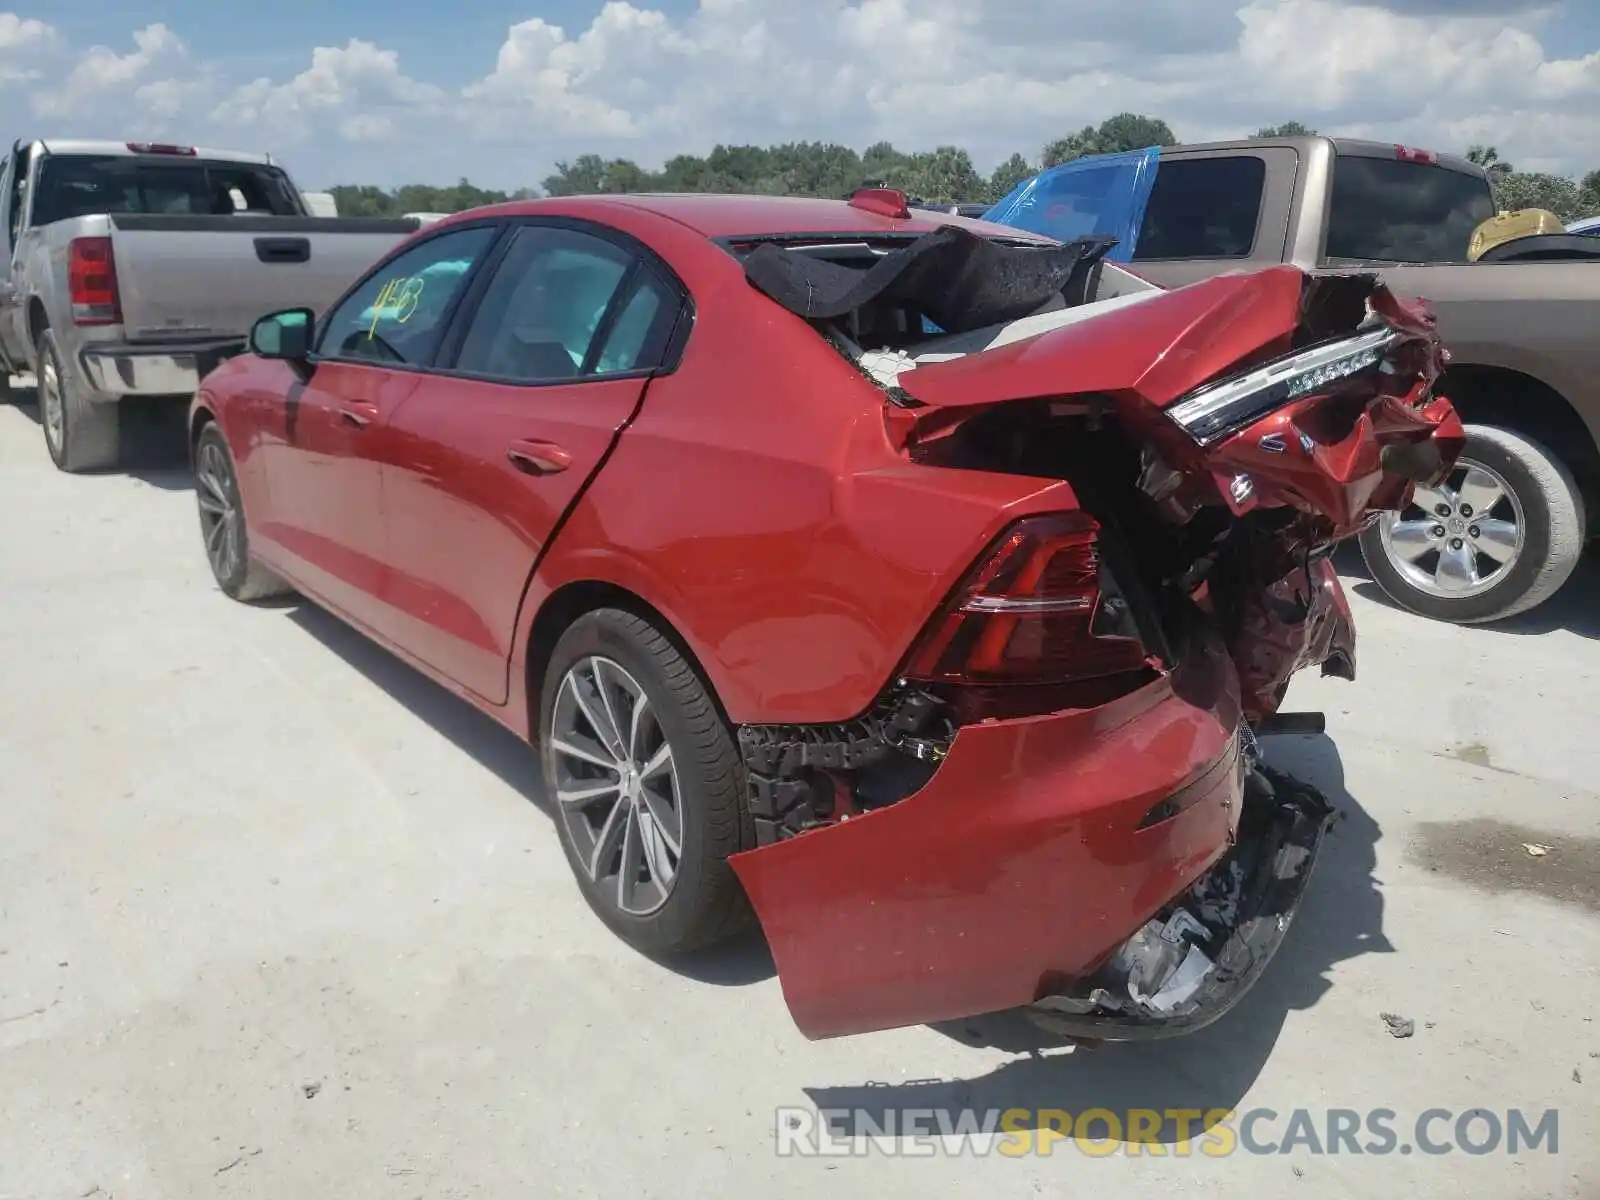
317, 226, 499, 366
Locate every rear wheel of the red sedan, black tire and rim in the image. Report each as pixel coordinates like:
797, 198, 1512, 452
539, 608, 755, 955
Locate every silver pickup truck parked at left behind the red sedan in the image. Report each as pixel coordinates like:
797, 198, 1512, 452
0, 141, 419, 472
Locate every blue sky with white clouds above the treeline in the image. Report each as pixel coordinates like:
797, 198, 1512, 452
0, 0, 1600, 187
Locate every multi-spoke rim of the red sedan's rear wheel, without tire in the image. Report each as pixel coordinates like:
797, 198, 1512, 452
549, 654, 683, 917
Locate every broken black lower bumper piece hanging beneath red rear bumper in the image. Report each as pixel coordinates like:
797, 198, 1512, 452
1024, 766, 1334, 1042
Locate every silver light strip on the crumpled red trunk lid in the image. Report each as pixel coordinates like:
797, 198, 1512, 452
1166, 325, 1400, 446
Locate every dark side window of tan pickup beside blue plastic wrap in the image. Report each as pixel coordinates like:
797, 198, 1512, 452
1133, 154, 1267, 262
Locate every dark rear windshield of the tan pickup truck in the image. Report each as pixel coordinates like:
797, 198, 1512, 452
1323, 155, 1494, 262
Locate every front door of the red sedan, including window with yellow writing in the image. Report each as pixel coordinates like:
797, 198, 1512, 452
259, 226, 499, 632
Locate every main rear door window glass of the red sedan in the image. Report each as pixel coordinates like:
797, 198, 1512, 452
456, 226, 634, 382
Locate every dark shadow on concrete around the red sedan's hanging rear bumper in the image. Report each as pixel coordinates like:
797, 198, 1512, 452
805, 736, 1394, 1146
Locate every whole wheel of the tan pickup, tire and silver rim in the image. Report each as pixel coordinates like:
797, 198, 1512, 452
1360, 426, 1586, 624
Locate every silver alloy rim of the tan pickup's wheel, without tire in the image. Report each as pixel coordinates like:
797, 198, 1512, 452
1378, 458, 1528, 600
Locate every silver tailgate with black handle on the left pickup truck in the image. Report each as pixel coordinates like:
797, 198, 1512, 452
110, 214, 419, 341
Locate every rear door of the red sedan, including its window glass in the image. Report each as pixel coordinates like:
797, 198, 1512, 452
384, 222, 683, 702
